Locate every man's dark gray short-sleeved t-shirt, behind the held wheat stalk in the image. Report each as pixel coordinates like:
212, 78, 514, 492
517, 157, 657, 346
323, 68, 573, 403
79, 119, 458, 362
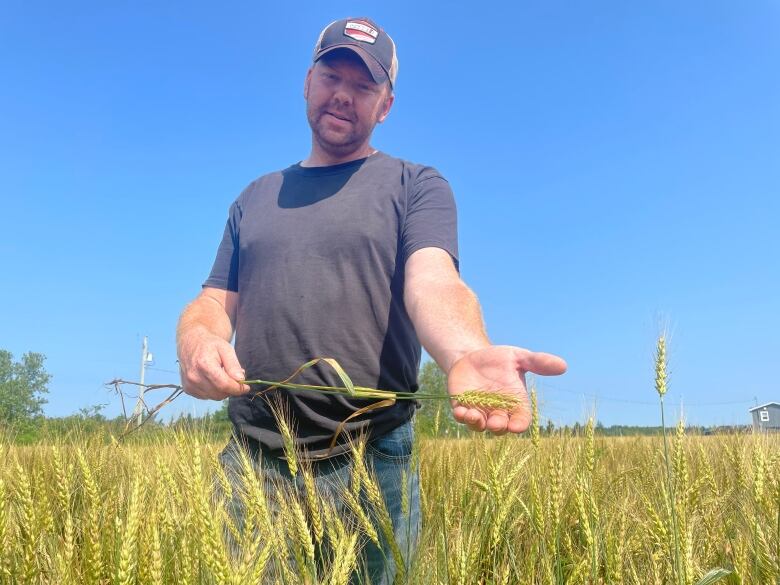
203, 152, 458, 457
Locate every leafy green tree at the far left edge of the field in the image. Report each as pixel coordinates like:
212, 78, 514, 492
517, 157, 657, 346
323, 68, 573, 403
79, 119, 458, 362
0, 349, 51, 425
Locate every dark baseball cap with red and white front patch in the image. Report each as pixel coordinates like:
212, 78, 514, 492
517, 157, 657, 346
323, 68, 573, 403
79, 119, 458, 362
312, 16, 398, 87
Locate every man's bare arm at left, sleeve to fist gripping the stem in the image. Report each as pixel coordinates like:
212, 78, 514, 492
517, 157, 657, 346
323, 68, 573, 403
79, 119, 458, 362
176, 287, 249, 400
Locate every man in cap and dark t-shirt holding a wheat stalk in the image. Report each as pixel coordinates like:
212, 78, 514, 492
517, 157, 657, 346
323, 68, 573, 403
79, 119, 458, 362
177, 18, 566, 582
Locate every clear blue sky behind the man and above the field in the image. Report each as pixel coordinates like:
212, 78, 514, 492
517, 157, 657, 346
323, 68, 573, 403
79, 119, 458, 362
0, 1, 780, 425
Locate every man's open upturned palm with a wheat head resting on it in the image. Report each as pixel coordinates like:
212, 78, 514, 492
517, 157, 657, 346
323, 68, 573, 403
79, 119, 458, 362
447, 345, 566, 435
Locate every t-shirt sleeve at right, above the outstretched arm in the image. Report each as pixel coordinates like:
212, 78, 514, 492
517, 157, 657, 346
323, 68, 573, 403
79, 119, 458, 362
401, 168, 460, 270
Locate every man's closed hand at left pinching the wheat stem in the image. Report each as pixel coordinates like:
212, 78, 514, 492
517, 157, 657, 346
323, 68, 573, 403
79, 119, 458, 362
179, 329, 249, 400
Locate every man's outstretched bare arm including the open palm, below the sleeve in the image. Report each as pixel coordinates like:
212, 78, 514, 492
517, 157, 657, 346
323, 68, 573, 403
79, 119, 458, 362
404, 247, 566, 434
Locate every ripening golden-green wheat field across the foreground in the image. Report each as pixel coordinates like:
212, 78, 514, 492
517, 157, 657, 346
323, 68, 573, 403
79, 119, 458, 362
0, 423, 780, 585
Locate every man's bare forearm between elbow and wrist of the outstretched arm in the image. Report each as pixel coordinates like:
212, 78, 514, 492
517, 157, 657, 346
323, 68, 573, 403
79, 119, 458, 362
404, 278, 490, 373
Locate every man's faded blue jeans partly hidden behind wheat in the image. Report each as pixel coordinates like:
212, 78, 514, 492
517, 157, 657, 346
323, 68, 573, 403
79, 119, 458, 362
220, 421, 420, 585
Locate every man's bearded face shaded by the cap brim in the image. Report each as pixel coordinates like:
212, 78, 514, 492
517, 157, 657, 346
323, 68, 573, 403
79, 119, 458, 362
304, 50, 393, 156
